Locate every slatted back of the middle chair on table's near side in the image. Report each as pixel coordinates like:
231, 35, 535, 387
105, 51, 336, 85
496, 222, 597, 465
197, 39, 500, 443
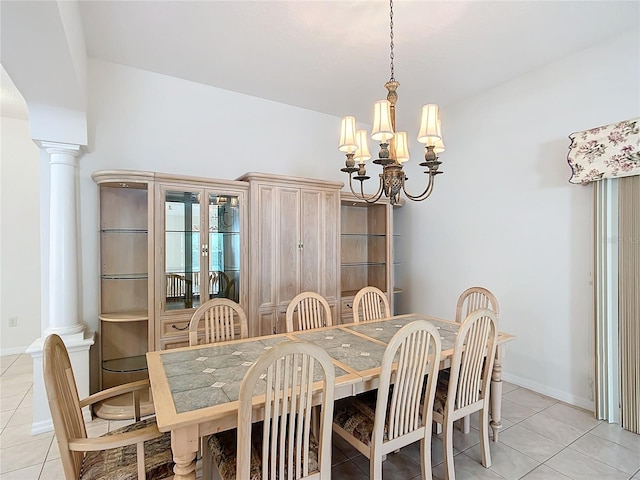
372, 320, 442, 444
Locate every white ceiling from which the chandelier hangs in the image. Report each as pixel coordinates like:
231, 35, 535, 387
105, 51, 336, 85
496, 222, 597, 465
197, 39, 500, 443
2, 0, 640, 128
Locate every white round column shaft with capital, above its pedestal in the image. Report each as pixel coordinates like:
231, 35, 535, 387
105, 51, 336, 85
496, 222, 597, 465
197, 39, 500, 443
42, 142, 84, 336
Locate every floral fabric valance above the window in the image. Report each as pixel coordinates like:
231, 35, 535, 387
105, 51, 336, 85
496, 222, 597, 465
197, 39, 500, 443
567, 118, 640, 184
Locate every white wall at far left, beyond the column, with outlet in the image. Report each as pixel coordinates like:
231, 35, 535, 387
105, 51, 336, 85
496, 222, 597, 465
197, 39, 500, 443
0, 117, 40, 355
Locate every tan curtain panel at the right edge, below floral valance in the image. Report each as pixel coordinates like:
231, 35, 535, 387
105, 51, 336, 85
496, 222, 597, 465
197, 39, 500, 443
618, 176, 640, 433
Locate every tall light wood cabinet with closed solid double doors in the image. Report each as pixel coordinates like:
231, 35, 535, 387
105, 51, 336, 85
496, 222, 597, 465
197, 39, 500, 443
240, 173, 343, 336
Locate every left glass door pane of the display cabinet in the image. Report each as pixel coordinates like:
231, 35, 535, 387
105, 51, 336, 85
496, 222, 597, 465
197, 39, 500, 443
164, 190, 202, 310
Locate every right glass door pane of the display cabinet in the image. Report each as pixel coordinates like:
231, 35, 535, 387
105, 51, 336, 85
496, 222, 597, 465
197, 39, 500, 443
208, 193, 241, 303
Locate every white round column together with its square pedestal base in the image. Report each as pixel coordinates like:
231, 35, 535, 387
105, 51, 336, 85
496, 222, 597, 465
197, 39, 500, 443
27, 142, 94, 434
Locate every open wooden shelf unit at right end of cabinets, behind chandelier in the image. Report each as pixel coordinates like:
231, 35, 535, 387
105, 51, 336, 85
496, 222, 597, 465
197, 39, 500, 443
340, 192, 401, 323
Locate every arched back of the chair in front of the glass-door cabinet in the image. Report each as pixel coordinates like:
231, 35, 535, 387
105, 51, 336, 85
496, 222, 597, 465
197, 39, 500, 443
189, 298, 249, 346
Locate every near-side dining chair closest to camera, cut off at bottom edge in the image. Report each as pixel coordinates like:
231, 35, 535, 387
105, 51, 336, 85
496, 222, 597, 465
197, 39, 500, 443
208, 341, 335, 480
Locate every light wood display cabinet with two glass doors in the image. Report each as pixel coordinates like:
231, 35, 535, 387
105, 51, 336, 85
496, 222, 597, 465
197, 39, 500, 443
155, 175, 248, 349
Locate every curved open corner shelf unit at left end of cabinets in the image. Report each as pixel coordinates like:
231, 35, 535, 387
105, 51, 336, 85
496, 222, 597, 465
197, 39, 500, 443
93, 171, 154, 419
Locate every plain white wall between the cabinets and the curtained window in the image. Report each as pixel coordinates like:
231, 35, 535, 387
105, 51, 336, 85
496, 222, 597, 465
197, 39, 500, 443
398, 33, 640, 408
